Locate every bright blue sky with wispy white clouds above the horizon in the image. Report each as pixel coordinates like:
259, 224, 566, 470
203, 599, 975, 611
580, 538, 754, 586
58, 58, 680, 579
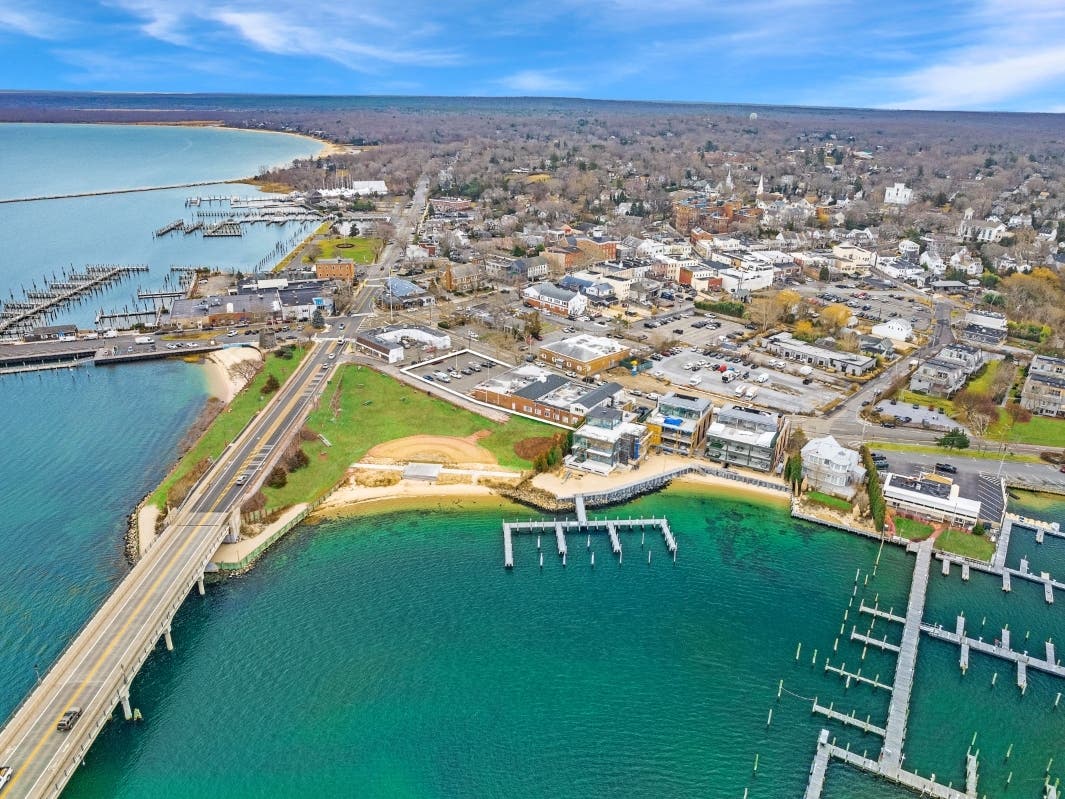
0, 0, 1065, 112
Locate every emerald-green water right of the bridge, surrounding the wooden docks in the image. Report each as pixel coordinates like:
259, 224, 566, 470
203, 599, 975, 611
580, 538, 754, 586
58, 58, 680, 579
67, 490, 1065, 799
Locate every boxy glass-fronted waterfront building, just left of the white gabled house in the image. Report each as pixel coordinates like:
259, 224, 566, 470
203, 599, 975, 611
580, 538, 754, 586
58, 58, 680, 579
706, 405, 788, 472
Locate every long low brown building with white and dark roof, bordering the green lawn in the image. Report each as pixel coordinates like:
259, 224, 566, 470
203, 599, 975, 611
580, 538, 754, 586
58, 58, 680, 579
470, 363, 622, 427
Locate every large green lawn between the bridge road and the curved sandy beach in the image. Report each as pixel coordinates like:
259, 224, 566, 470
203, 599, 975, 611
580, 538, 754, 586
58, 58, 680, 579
263, 364, 558, 508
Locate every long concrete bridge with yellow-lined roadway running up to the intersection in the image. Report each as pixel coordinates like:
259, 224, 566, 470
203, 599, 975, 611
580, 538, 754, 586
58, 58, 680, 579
0, 336, 342, 799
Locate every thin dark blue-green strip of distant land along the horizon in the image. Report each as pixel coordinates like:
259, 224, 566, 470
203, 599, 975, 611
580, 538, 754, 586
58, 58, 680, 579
0, 87, 1065, 116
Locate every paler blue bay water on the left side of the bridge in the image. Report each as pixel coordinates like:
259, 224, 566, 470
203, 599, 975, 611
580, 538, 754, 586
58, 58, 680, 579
0, 125, 316, 717
